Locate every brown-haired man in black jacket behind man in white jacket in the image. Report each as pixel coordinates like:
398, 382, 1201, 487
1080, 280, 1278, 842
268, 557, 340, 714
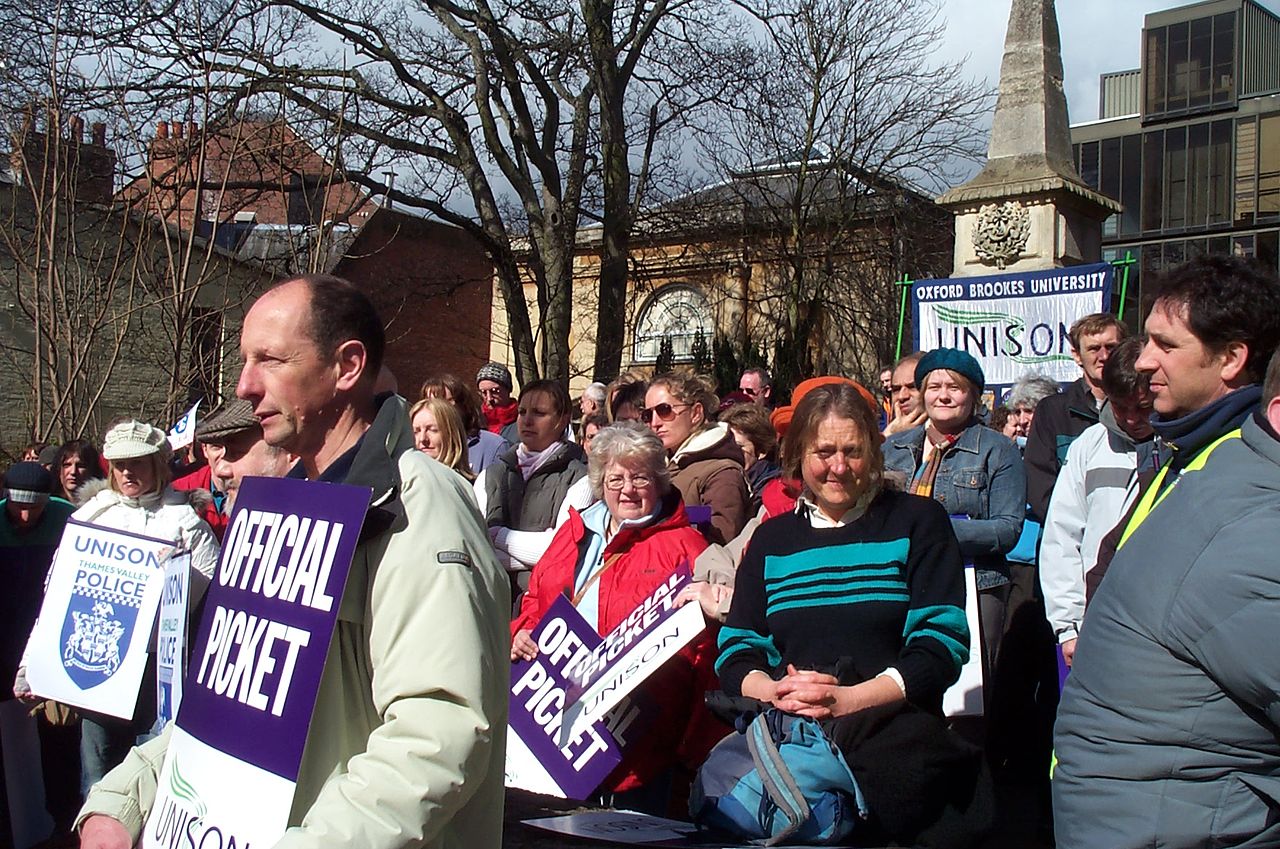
1023, 312, 1129, 522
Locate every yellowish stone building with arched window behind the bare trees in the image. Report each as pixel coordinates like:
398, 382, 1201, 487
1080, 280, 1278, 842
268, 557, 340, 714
490, 158, 952, 391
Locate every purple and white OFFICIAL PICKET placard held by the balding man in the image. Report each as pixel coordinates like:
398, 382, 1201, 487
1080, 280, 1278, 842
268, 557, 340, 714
143, 478, 370, 848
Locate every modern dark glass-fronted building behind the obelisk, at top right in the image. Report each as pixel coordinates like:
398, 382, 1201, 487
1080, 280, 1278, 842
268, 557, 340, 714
1071, 0, 1280, 324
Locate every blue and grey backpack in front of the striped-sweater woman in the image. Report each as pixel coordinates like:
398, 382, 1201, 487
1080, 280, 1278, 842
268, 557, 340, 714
689, 709, 868, 846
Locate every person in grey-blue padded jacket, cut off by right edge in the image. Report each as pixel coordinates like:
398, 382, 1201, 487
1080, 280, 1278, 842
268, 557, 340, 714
1053, 348, 1280, 849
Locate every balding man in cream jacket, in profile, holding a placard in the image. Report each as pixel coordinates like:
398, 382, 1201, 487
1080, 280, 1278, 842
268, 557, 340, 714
81, 277, 511, 849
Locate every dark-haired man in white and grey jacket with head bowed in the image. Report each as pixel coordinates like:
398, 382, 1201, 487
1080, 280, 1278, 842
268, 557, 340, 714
1039, 338, 1156, 665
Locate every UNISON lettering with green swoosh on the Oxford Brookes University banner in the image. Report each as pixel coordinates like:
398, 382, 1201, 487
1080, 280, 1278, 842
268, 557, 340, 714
933, 305, 1071, 365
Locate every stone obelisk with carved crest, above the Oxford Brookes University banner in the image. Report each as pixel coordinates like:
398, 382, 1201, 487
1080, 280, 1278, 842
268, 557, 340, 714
938, 0, 1120, 277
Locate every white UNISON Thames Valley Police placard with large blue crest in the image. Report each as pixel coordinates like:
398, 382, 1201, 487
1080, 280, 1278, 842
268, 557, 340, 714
26, 519, 174, 718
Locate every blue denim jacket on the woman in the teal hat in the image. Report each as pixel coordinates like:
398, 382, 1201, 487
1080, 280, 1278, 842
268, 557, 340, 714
884, 423, 1027, 589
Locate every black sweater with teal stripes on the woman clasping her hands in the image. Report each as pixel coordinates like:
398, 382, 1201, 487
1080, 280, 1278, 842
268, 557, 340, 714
716, 492, 969, 712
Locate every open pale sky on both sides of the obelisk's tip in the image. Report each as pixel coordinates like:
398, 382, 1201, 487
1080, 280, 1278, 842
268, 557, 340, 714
941, 0, 1280, 124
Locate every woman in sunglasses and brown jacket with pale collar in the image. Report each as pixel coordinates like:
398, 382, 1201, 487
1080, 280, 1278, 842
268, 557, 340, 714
640, 371, 751, 546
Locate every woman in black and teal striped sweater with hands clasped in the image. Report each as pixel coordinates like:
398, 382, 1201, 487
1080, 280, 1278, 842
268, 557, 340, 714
712, 384, 991, 846
